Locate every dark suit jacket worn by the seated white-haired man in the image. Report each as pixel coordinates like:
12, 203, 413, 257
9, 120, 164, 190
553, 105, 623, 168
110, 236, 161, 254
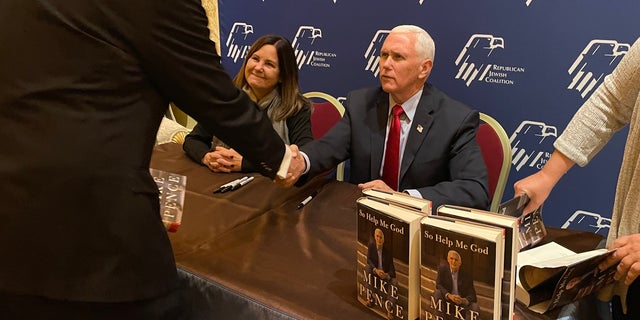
300, 84, 489, 210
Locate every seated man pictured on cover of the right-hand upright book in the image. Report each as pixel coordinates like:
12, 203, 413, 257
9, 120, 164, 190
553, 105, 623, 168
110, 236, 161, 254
434, 250, 480, 319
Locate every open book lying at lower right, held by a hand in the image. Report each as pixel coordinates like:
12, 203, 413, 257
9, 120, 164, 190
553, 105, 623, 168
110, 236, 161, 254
516, 248, 617, 313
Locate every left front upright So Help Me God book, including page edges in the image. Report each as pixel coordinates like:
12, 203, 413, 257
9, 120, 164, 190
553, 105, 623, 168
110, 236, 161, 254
356, 197, 424, 320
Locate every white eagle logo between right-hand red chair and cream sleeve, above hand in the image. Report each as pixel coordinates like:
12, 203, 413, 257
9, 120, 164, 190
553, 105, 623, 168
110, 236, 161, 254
509, 120, 558, 171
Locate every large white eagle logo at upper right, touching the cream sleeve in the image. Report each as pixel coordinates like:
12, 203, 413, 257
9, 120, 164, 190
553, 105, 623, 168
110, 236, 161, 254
567, 39, 630, 98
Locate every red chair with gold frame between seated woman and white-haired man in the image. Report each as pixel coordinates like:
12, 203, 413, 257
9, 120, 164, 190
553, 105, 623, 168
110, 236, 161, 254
304, 91, 344, 181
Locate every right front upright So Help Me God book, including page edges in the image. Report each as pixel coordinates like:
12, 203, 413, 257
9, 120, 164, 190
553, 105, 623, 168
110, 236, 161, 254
420, 216, 504, 320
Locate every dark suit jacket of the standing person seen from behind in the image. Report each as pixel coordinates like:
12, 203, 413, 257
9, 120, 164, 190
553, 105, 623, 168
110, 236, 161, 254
0, 0, 284, 302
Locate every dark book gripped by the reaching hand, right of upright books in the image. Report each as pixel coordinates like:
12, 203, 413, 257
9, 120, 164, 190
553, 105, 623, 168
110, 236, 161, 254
498, 194, 547, 250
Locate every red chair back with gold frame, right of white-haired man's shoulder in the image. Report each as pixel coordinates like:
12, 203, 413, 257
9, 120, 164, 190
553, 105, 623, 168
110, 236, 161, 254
476, 112, 511, 212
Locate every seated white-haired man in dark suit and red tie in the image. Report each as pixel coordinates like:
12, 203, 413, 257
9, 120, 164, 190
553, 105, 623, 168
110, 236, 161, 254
284, 26, 489, 209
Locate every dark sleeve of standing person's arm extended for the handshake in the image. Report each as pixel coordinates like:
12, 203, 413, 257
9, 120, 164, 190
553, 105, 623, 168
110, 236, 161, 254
131, 0, 285, 178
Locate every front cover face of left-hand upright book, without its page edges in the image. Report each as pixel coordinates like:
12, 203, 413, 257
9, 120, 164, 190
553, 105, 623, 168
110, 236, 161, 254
357, 218, 409, 319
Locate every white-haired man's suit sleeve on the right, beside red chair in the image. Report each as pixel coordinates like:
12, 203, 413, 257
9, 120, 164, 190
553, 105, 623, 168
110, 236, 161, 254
417, 111, 489, 209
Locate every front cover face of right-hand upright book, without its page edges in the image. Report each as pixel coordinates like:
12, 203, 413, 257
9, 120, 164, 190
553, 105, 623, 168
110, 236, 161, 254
420, 229, 502, 320
